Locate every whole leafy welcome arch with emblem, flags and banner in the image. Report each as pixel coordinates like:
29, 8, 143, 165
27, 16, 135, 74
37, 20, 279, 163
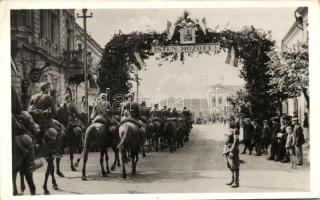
97, 12, 275, 117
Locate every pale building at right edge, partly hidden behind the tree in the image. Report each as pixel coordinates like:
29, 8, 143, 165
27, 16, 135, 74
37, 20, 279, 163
281, 7, 308, 122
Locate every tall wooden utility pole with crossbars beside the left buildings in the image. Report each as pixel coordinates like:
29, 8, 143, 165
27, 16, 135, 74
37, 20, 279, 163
77, 9, 92, 122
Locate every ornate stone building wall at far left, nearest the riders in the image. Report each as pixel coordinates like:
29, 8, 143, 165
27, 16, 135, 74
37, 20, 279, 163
11, 9, 79, 109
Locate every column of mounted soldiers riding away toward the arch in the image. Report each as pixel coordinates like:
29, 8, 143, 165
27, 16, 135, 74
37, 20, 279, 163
12, 82, 192, 195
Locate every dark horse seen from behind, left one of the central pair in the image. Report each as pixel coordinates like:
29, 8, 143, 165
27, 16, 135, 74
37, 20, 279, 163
74, 122, 120, 181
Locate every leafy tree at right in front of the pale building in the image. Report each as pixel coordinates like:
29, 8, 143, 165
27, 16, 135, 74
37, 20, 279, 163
268, 43, 309, 111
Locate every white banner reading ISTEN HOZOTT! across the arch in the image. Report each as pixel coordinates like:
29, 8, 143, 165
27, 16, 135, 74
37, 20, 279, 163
151, 43, 220, 53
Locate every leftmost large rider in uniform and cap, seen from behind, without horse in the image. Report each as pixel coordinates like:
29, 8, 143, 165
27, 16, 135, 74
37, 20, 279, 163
28, 82, 57, 140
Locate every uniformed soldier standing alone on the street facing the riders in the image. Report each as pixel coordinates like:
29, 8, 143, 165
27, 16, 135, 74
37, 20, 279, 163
222, 116, 240, 188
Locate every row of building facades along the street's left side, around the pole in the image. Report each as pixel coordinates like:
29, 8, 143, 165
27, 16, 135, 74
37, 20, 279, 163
11, 9, 102, 112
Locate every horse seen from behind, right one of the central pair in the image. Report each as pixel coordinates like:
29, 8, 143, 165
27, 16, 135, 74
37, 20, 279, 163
117, 121, 141, 178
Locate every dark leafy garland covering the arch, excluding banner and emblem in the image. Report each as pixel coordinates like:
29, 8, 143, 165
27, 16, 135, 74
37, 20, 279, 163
97, 12, 277, 118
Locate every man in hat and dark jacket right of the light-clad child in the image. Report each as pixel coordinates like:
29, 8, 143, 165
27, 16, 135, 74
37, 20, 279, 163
292, 117, 305, 166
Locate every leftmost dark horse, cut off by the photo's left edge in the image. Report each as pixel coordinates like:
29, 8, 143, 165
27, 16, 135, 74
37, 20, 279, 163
12, 111, 42, 195
